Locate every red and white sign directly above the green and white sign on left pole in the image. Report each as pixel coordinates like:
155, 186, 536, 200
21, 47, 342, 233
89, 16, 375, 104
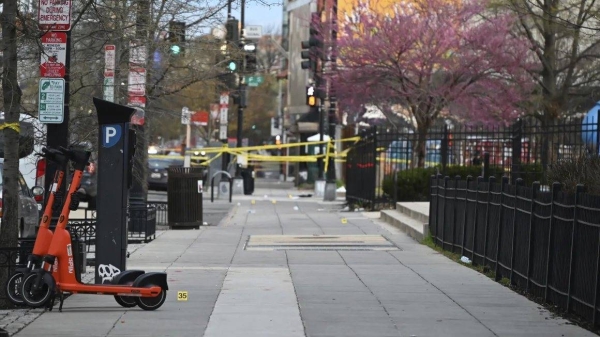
40, 32, 67, 78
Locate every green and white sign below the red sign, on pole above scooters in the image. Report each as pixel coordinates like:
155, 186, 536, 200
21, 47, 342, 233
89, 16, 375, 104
38, 78, 65, 124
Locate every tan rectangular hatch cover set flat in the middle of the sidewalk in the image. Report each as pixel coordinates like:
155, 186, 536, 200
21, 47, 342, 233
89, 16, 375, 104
245, 235, 401, 250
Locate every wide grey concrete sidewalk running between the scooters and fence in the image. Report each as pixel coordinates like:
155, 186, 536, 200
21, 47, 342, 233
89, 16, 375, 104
5, 190, 593, 337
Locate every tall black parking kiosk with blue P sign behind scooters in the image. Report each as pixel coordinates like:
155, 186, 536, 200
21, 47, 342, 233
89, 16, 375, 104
94, 97, 135, 283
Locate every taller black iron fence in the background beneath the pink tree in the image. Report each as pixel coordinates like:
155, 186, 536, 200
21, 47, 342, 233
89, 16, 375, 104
346, 120, 600, 209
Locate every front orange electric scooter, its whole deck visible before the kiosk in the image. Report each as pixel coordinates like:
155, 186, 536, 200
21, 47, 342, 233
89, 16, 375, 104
21, 148, 168, 311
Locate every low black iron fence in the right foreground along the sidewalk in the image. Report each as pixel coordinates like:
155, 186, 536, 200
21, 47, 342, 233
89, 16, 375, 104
429, 175, 600, 324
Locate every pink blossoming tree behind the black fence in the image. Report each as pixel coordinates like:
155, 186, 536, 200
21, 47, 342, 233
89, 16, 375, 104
329, 0, 533, 167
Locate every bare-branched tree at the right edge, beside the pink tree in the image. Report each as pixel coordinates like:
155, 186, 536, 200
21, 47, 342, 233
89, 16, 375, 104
499, 0, 600, 165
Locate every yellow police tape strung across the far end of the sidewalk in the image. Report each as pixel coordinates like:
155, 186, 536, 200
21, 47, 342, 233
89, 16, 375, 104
149, 137, 360, 167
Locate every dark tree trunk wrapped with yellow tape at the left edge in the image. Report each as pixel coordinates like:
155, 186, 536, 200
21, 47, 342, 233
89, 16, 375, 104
0, 0, 21, 308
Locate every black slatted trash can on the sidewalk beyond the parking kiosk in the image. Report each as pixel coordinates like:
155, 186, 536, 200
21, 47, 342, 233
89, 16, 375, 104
167, 167, 205, 229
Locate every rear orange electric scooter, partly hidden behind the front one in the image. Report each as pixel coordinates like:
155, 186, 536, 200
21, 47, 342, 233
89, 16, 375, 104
5, 148, 67, 305
